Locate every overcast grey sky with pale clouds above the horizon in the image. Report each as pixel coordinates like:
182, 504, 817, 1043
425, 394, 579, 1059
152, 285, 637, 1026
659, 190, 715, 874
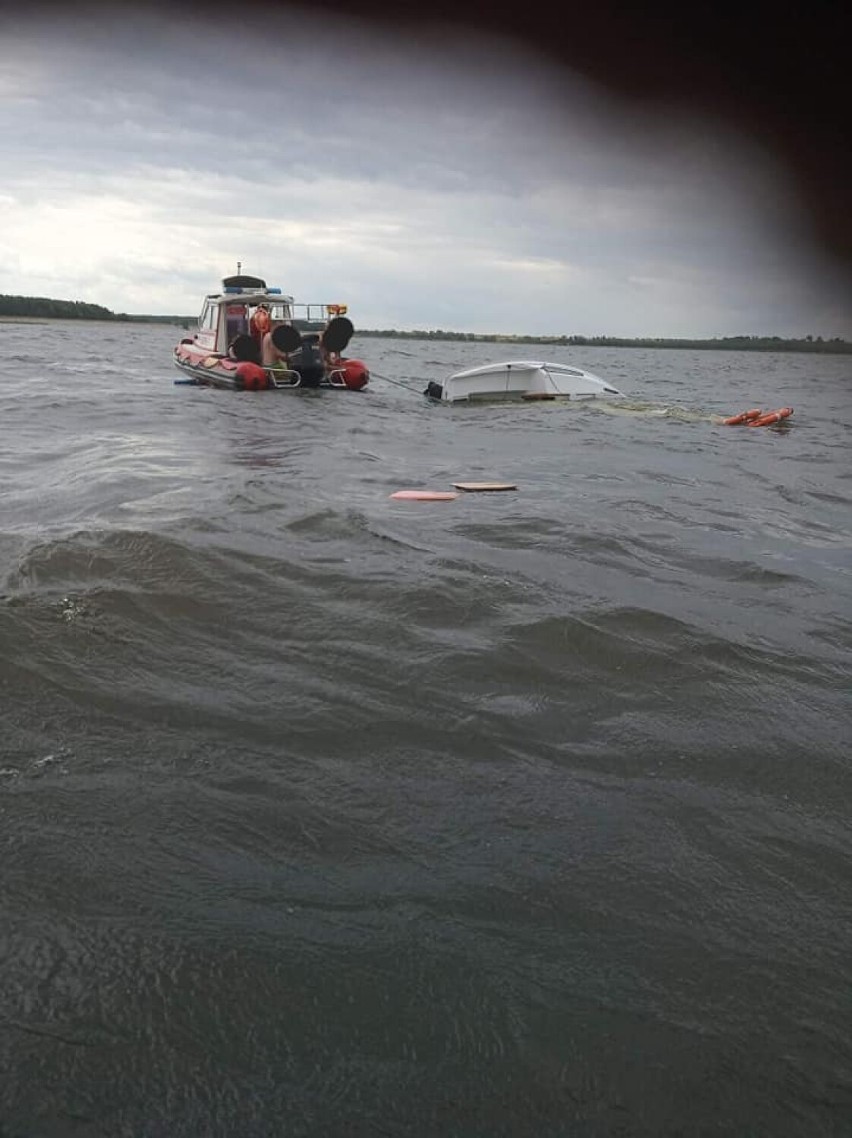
0, 5, 852, 337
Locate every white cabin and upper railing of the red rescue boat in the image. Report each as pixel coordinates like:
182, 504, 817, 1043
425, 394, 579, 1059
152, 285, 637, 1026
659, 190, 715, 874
193, 275, 346, 355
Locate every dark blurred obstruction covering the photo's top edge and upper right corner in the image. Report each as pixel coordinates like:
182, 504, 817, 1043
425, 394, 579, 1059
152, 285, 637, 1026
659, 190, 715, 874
23, 0, 852, 279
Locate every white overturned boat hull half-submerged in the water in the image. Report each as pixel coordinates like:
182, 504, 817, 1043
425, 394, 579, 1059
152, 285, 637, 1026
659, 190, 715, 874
425, 360, 624, 403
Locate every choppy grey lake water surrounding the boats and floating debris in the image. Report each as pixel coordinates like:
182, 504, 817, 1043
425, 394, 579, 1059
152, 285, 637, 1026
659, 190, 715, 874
0, 323, 852, 1138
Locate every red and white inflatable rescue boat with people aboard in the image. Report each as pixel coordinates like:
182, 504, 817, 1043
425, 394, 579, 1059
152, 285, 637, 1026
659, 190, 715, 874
174, 273, 370, 391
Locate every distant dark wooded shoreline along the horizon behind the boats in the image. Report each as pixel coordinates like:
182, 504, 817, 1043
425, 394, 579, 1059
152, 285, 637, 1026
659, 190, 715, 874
0, 296, 852, 355
